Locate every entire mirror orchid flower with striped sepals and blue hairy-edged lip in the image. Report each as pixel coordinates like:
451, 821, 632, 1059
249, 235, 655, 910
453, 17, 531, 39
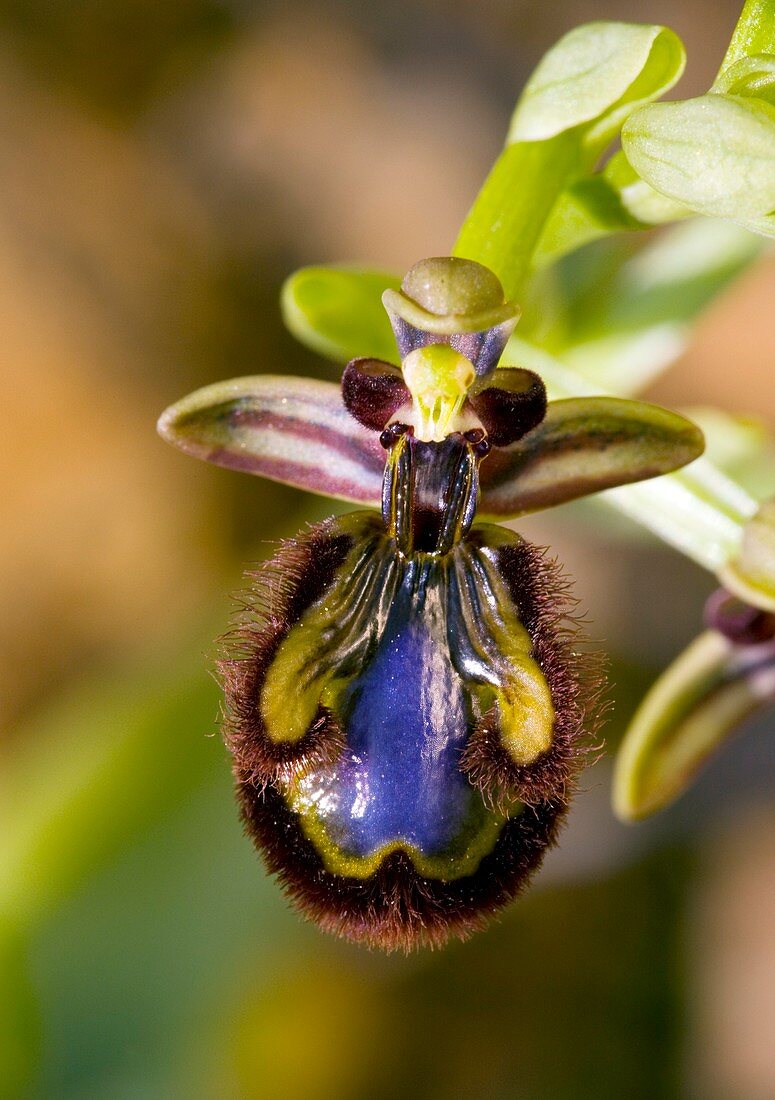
158, 257, 704, 949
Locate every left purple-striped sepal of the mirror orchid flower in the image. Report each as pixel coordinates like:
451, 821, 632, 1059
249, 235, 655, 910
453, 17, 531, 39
158, 374, 385, 505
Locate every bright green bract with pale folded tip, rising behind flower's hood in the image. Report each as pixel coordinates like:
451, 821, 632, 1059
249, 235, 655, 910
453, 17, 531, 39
455, 22, 685, 297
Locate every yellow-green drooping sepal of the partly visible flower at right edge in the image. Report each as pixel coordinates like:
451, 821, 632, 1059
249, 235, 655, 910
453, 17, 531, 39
613, 630, 775, 821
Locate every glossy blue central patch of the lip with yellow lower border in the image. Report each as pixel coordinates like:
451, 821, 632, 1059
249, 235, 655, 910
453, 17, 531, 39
289, 559, 502, 879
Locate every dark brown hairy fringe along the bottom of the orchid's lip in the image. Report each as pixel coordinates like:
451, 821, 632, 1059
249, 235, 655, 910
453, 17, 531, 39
235, 768, 566, 953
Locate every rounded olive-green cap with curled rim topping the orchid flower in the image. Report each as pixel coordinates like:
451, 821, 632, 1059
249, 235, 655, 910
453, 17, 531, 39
383, 256, 519, 336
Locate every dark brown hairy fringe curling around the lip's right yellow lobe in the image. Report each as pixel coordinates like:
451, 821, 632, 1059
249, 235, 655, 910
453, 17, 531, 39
462, 541, 606, 806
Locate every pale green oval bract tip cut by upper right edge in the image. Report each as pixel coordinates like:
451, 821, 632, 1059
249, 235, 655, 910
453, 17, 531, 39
622, 94, 775, 233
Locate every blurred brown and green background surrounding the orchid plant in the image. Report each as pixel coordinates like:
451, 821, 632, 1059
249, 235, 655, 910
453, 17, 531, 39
0, 0, 775, 1100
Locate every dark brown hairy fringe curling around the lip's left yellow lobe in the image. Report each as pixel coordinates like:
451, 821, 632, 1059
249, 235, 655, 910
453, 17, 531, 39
217, 519, 352, 785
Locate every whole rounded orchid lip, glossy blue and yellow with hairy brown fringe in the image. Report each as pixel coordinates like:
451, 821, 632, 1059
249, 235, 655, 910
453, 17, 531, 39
221, 512, 582, 949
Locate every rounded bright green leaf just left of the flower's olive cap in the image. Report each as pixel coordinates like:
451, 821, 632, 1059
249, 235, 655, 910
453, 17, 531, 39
280, 266, 400, 363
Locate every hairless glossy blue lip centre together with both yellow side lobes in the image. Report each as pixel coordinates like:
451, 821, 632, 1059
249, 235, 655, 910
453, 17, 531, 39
258, 513, 554, 880
